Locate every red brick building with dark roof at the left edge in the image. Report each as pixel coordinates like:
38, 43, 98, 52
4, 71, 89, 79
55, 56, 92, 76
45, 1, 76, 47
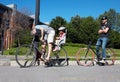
0, 4, 34, 51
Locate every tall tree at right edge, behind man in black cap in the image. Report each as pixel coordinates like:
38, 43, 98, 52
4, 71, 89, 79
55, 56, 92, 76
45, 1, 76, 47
98, 9, 120, 48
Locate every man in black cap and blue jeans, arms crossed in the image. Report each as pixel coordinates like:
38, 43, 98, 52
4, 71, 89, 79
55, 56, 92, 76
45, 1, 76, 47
96, 16, 111, 63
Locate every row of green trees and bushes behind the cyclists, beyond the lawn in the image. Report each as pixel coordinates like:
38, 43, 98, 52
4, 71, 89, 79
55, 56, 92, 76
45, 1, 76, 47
14, 9, 120, 48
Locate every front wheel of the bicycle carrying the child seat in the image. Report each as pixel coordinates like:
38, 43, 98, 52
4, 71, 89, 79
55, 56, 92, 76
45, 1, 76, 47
15, 45, 36, 67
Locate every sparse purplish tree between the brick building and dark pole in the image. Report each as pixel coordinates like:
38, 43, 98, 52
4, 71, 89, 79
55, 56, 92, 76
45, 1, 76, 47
13, 9, 34, 46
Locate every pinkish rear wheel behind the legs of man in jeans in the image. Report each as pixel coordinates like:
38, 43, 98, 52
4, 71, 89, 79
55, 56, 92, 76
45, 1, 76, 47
106, 48, 116, 65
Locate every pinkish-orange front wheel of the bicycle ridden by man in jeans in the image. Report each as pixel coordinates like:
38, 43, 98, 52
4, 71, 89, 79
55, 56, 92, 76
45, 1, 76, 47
76, 48, 95, 66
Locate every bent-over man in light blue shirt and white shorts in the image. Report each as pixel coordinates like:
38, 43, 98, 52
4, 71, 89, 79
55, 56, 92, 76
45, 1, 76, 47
32, 24, 55, 62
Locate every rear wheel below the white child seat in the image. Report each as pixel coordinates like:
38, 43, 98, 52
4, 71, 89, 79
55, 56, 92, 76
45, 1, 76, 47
51, 47, 69, 66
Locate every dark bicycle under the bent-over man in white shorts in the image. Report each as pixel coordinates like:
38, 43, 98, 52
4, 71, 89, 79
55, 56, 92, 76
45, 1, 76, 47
15, 37, 69, 67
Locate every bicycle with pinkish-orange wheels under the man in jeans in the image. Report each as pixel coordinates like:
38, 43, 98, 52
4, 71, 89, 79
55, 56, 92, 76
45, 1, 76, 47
76, 40, 115, 66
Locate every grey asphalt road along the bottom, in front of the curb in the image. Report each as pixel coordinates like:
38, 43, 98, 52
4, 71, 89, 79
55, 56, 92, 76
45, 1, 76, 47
0, 64, 120, 82
